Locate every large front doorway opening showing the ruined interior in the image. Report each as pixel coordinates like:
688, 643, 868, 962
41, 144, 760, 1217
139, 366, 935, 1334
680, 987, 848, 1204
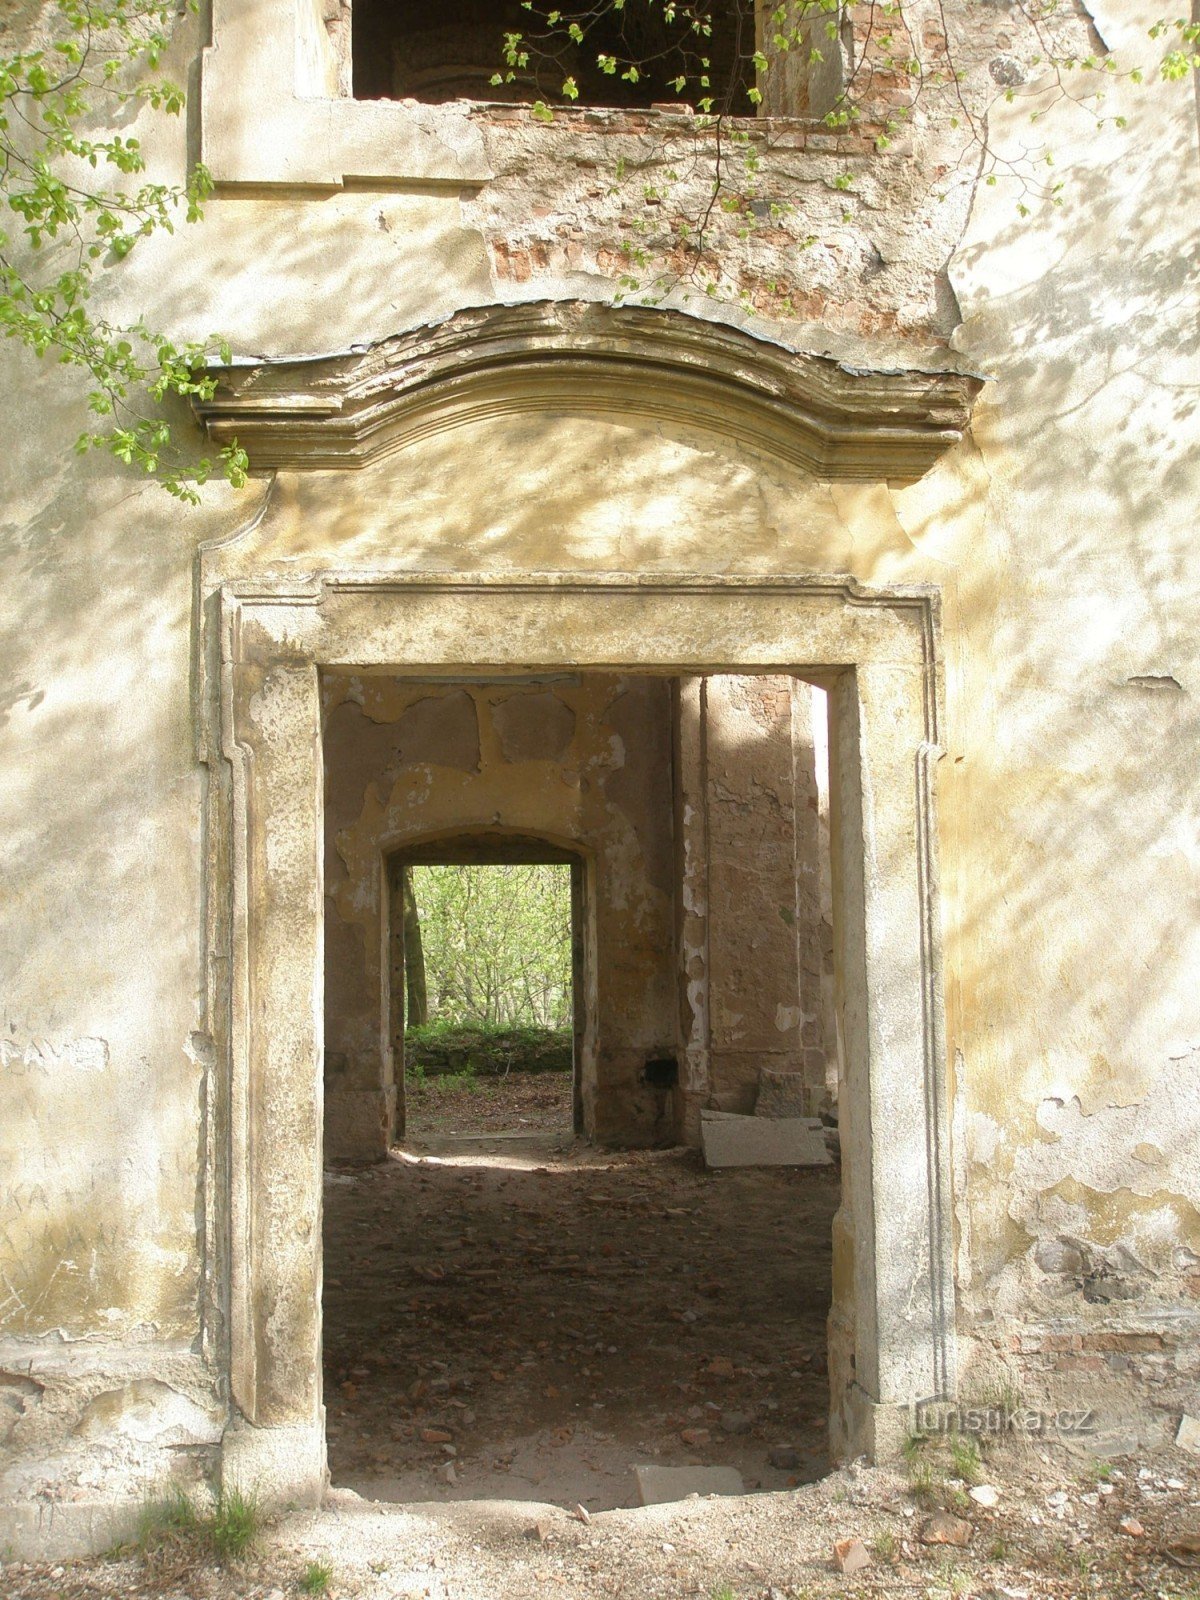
323, 670, 842, 1510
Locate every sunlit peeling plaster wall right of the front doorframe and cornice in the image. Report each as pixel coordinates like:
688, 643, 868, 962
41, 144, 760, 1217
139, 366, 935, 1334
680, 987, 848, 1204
940, 5, 1200, 1453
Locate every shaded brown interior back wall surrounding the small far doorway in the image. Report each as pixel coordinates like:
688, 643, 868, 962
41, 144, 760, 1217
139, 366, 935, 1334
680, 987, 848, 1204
325, 674, 677, 1160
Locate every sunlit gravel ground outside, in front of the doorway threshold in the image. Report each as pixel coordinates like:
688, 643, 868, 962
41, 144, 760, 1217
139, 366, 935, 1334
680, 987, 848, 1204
0, 1446, 1200, 1600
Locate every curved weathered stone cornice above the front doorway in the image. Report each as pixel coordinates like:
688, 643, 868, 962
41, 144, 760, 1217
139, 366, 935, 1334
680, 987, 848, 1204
194, 301, 982, 480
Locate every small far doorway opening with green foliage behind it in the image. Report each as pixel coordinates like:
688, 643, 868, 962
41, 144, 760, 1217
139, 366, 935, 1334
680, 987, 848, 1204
389, 838, 584, 1149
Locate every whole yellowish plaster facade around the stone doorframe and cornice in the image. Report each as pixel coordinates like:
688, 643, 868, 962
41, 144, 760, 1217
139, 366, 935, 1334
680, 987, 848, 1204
0, 0, 1200, 1549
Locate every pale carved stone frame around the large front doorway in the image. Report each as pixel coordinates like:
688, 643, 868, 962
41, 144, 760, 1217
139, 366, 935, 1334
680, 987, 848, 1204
209, 569, 955, 1502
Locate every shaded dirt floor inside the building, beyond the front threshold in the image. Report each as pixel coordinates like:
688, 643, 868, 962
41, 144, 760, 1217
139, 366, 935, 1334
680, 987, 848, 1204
325, 1120, 838, 1512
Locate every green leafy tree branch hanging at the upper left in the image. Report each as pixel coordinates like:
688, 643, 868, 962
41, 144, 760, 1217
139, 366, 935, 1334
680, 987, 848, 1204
0, 0, 248, 502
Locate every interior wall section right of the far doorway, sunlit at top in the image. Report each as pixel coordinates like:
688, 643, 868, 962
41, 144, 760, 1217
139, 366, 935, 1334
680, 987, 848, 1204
675, 674, 835, 1139
